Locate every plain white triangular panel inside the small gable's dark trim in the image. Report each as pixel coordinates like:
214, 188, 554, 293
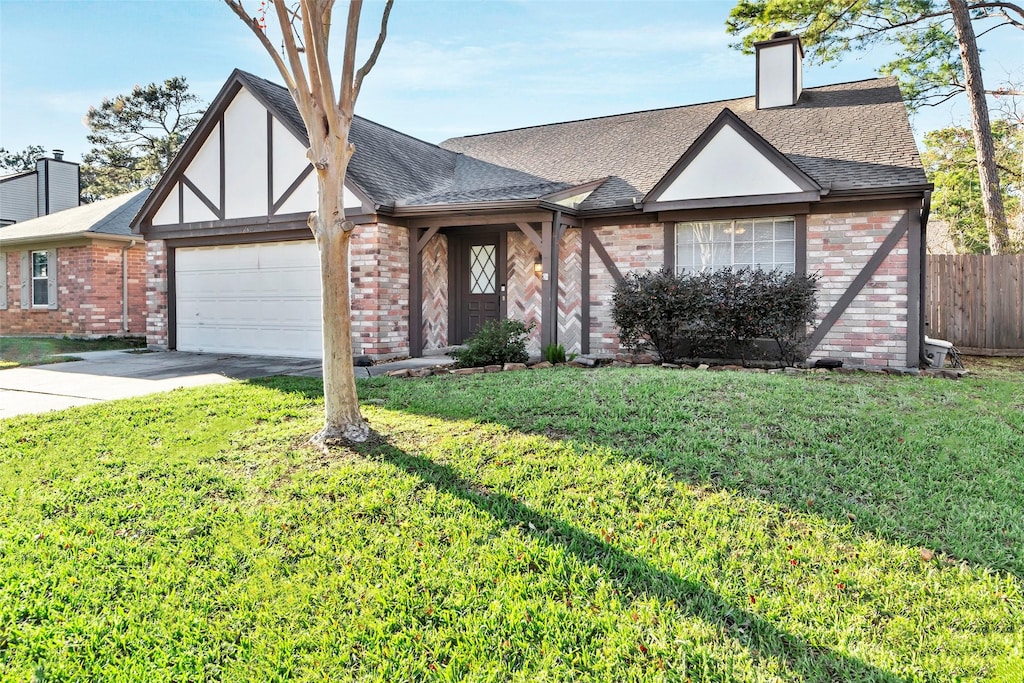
657, 125, 801, 202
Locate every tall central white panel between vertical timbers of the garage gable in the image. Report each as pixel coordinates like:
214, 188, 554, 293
224, 88, 267, 220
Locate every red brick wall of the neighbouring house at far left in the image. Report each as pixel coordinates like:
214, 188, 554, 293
0, 244, 145, 337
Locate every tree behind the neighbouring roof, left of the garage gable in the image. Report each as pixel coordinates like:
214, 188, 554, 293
82, 77, 206, 202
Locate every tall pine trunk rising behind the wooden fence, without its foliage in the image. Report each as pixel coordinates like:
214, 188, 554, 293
949, 0, 1008, 254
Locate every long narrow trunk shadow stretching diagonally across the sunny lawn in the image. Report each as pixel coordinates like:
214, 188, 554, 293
356, 433, 903, 682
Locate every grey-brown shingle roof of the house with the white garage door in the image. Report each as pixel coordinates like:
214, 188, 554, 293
237, 71, 927, 209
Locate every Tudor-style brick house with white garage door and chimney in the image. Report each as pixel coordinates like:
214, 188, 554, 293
135, 37, 931, 367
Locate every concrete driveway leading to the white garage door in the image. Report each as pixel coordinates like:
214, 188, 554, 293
0, 351, 323, 419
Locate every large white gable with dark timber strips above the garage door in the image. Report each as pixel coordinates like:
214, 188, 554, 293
140, 78, 364, 226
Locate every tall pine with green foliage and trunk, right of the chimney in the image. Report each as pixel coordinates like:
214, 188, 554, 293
726, 0, 1024, 254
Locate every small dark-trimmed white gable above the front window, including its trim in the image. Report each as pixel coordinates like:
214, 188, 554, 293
644, 109, 820, 206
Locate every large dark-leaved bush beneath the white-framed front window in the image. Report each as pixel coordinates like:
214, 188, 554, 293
612, 268, 817, 364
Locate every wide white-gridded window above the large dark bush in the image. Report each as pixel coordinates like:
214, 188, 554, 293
676, 216, 797, 272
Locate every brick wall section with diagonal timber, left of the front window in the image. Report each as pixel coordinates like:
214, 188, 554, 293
588, 223, 665, 355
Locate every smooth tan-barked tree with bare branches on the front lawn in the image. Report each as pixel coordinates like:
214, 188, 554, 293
224, 0, 392, 449
